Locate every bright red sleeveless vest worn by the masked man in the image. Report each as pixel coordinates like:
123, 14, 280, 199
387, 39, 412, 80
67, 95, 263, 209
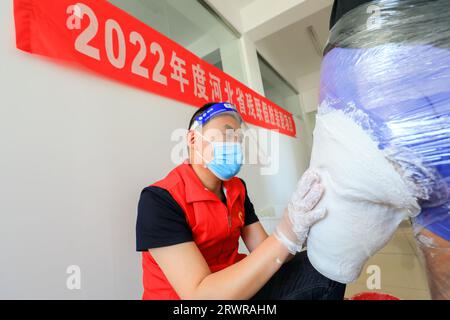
142, 163, 246, 300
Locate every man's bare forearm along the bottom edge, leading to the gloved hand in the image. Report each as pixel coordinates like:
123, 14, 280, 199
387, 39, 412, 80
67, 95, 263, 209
190, 236, 290, 300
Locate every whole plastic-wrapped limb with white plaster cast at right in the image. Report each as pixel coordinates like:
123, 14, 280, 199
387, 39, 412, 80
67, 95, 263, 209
308, 0, 450, 299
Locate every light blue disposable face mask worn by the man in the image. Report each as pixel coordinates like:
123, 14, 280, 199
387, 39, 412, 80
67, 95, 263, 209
197, 141, 243, 180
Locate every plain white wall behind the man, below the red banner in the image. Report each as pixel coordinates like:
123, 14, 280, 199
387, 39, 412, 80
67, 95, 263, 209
0, 1, 309, 299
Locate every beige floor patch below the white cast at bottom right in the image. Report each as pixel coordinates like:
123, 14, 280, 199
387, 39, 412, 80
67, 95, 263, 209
345, 221, 430, 300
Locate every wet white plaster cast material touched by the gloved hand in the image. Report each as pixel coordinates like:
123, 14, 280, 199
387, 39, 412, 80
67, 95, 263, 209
307, 111, 420, 283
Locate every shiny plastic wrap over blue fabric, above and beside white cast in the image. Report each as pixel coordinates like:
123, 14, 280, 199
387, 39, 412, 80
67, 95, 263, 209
319, 0, 450, 299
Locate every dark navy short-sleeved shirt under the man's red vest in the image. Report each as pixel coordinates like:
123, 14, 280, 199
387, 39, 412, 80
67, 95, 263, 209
136, 179, 259, 251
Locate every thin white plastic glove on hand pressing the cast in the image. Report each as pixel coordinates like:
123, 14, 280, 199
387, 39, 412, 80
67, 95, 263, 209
274, 170, 326, 254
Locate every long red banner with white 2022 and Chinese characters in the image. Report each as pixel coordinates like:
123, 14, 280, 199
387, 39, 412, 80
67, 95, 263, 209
14, 0, 296, 136
